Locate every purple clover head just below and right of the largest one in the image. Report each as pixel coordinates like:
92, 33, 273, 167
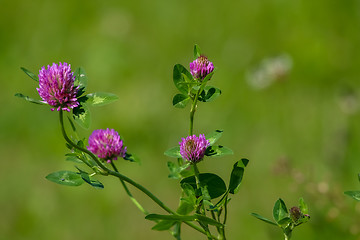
87, 128, 126, 163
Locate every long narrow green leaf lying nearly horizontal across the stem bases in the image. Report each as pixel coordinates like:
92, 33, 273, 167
145, 214, 224, 227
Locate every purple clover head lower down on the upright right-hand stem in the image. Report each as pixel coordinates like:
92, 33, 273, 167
179, 134, 210, 163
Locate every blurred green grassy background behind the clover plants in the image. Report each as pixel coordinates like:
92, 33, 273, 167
0, 0, 360, 240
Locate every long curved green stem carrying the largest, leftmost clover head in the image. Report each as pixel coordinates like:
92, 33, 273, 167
59, 111, 216, 239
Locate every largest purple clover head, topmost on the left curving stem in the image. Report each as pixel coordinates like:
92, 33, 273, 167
36, 62, 79, 112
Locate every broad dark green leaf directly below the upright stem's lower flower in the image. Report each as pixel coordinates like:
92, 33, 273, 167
180, 173, 226, 199
